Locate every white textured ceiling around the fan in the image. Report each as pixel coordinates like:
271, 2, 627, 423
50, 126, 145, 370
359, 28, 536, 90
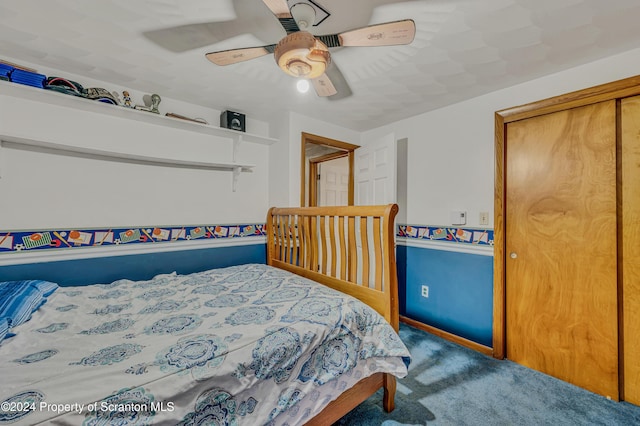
0, 0, 640, 130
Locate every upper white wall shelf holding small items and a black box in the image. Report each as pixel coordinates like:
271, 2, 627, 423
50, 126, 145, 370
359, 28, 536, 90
0, 80, 278, 145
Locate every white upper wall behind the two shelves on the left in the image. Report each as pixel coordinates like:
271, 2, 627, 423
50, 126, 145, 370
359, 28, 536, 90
0, 57, 269, 230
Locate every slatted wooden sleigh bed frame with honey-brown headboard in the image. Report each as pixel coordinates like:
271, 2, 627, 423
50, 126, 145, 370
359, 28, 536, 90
267, 204, 399, 425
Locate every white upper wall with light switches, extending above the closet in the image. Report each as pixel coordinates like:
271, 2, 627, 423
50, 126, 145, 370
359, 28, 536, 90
360, 49, 640, 227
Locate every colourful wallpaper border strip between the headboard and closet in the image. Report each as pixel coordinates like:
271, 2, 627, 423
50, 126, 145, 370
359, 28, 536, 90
396, 225, 493, 246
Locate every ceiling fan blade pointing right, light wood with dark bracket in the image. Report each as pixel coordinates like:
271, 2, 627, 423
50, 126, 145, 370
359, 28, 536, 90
316, 19, 416, 47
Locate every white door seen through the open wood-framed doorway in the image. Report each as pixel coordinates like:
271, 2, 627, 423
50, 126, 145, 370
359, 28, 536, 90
318, 157, 349, 206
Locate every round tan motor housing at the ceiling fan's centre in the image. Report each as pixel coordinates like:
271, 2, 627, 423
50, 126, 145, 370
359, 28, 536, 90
274, 31, 331, 79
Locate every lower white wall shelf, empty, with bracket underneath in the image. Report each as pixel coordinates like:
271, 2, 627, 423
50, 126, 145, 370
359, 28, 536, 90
0, 134, 255, 192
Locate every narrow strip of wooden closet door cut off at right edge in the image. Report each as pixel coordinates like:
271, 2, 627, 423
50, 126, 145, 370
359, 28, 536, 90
618, 96, 640, 405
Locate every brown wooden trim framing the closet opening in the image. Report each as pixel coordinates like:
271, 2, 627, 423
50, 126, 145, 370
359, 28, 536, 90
493, 76, 640, 359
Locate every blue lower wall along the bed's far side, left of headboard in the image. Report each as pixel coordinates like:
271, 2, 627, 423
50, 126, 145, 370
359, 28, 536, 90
0, 244, 266, 286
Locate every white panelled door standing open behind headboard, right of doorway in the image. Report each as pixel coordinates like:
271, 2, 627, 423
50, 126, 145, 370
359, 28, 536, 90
355, 133, 397, 205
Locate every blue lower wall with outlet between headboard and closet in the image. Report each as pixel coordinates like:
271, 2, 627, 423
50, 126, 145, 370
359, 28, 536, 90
396, 245, 493, 347
